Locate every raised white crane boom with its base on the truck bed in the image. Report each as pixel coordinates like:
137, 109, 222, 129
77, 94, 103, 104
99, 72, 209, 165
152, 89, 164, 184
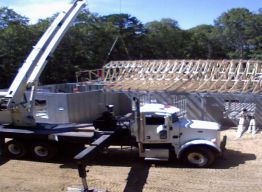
0, 0, 86, 126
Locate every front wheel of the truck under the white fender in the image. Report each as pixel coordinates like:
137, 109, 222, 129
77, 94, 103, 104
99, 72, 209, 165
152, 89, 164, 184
182, 147, 215, 168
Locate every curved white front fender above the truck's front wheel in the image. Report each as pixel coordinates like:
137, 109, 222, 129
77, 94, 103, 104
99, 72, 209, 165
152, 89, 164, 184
177, 140, 221, 159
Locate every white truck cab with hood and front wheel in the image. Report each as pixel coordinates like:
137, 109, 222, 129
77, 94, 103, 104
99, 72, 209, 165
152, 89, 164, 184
131, 103, 226, 167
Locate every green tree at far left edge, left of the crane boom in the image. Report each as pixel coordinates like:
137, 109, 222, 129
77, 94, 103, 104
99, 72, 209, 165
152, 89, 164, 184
0, 7, 33, 88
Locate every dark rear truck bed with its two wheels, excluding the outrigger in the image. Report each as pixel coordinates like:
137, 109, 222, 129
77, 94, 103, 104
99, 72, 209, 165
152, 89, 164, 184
0, 124, 114, 161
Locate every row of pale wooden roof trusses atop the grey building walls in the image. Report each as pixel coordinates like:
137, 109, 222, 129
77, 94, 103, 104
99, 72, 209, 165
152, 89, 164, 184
77, 60, 262, 94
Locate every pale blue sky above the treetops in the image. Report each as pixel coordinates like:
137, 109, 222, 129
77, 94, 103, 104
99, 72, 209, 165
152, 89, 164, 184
0, 0, 262, 29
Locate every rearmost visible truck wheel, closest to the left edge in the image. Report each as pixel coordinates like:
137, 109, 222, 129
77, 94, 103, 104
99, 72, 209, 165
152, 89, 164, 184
5, 140, 27, 159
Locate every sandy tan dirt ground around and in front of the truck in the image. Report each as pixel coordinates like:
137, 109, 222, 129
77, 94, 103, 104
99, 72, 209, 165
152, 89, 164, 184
0, 129, 262, 192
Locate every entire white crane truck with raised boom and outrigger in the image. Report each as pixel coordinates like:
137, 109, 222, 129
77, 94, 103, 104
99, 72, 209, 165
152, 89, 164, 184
0, 0, 226, 188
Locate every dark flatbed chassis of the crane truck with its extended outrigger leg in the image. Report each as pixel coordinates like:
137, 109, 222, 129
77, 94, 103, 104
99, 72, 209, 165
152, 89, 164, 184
0, 124, 136, 191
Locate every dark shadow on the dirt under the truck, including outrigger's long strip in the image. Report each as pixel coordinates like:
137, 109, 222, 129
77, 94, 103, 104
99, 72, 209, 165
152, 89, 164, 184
0, 148, 256, 192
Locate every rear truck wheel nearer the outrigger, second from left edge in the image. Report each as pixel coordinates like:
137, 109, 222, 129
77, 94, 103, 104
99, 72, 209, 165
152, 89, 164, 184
31, 142, 58, 161
